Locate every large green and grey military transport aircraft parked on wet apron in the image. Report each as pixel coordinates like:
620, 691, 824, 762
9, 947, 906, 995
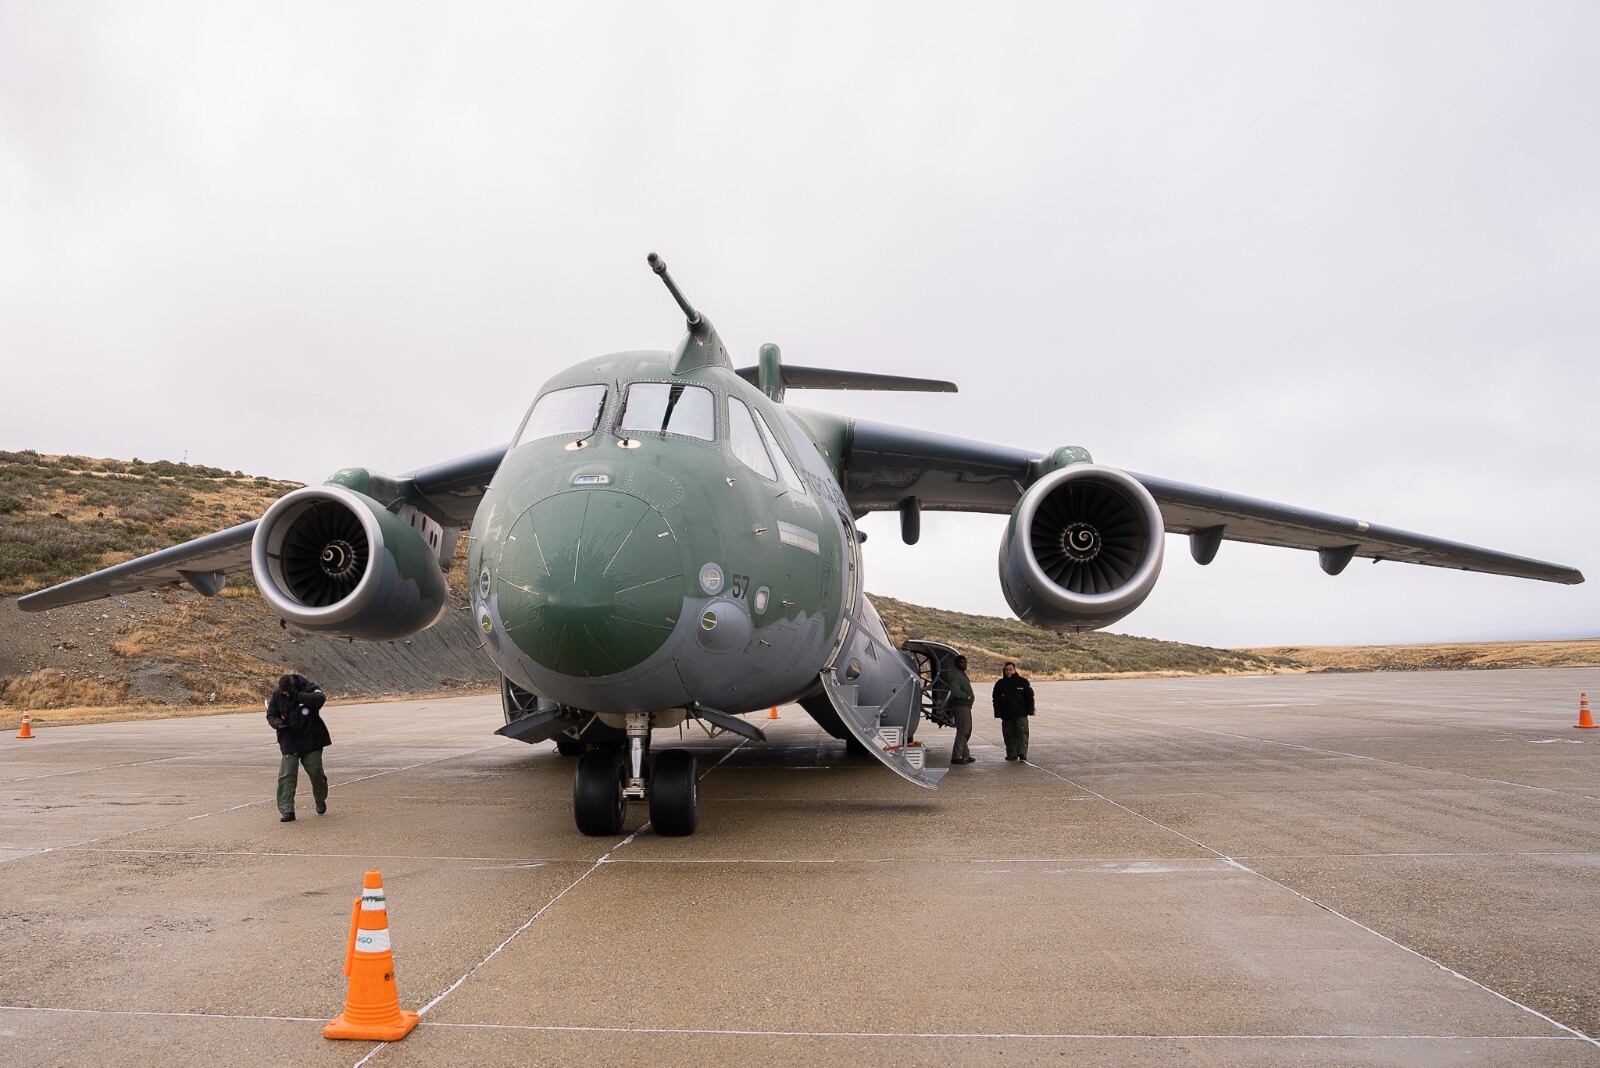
18, 253, 1582, 835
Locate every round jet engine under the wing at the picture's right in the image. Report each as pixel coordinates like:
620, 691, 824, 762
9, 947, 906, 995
1000, 464, 1165, 630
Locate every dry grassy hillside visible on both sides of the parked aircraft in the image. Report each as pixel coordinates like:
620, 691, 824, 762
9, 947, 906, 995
0, 451, 1600, 727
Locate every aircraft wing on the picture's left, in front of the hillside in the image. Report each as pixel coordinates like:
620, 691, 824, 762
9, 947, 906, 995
16, 446, 506, 612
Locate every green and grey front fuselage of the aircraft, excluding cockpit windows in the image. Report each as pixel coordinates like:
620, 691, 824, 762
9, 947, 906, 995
467, 352, 861, 713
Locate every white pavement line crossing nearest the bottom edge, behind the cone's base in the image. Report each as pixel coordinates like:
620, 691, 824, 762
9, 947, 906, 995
0, 1004, 1581, 1052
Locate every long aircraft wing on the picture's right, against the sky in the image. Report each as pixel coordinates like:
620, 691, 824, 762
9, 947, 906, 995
843, 419, 1584, 584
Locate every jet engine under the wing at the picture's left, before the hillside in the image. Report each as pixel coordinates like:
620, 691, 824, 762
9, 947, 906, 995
250, 484, 450, 641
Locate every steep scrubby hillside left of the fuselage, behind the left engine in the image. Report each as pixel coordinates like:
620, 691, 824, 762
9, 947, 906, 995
0, 451, 498, 726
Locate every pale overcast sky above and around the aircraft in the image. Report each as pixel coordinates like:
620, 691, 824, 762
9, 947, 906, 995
0, 0, 1600, 644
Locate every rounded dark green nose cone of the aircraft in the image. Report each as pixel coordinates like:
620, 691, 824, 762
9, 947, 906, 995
498, 489, 683, 678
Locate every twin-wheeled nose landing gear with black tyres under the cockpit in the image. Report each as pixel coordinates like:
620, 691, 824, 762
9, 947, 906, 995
573, 713, 699, 838
